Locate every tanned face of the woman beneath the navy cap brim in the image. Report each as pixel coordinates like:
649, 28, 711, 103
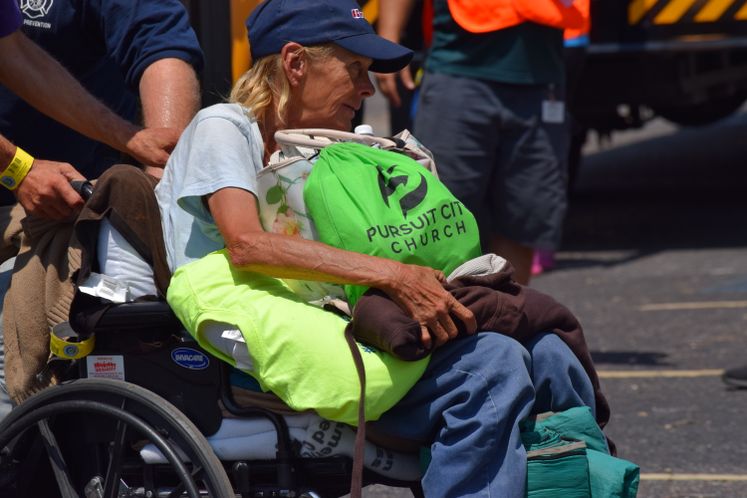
288, 45, 376, 131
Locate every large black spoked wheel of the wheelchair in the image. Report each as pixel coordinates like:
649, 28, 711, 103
0, 379, 235, 498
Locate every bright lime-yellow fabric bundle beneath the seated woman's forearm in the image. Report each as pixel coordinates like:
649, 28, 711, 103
167, 250, 428, 425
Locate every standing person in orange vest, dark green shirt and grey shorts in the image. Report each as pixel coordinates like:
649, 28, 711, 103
379, 0, 588, 284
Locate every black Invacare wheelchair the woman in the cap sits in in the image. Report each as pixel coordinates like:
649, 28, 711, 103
0, 301, 422, 498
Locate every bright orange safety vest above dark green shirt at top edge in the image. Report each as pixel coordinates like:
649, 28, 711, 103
448, 0, 589, 33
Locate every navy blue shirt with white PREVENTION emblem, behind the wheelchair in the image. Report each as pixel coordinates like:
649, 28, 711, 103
0, 0, 202, 205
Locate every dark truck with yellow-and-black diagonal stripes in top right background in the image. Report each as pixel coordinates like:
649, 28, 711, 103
572, 0, 747, 131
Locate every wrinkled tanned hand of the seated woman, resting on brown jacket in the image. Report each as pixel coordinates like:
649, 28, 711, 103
382, 264, 477, 349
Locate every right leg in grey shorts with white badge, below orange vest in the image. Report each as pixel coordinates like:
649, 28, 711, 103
494, 84, 568, 285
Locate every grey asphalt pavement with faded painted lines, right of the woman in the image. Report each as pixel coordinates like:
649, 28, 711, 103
356, 103, 747, 498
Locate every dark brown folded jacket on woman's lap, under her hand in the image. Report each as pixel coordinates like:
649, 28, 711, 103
351, 265, 610, 427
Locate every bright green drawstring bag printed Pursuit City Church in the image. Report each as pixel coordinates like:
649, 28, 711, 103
304, 142, 481, 306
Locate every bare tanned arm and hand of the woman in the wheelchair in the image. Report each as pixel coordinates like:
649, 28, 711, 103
208, 188, 476, 347
